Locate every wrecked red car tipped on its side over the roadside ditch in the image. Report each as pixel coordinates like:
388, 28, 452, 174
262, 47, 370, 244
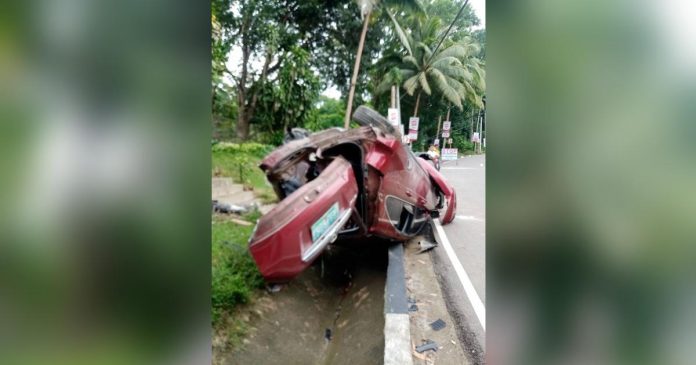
249, 106, 457, 283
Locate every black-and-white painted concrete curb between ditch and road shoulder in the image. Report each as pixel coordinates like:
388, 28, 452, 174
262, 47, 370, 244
384, 243, 413, 365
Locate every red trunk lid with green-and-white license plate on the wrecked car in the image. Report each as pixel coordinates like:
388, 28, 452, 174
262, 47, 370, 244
249, 156, 358, 282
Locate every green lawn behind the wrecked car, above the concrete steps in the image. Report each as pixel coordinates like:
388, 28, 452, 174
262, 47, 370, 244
212, 143, 278, 204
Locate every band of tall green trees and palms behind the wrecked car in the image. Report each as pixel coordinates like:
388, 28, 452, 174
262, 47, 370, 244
211, 0, 486, 152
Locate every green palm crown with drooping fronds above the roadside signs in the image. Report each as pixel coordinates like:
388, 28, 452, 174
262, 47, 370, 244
376, 14, 486, 116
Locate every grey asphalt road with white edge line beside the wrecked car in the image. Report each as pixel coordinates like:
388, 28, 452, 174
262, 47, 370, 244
435, 155, 486, 362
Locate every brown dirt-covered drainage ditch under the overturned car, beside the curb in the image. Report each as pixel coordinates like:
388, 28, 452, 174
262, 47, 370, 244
218, 240, 387, 365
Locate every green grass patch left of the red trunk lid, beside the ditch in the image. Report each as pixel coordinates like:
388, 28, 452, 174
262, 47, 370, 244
211, 213, 264, 325
